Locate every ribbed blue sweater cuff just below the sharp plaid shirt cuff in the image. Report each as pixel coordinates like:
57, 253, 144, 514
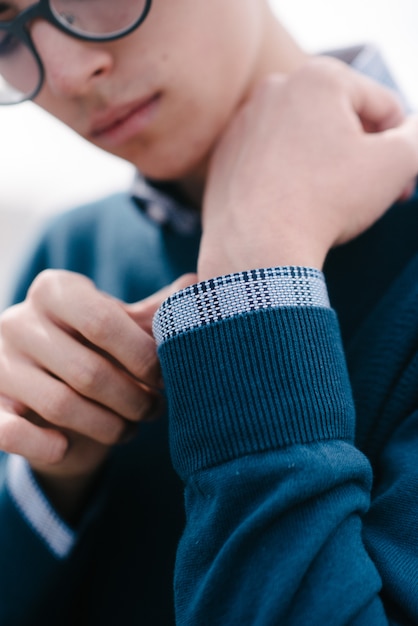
159, 307, 354, 479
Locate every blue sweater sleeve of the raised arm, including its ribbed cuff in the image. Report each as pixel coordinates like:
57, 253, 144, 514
155, 266, 389, 626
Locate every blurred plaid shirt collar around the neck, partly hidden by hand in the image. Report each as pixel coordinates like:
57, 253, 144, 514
131, 45, 409, 235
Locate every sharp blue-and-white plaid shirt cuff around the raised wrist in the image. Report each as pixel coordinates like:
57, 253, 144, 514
153, 266, 330, 345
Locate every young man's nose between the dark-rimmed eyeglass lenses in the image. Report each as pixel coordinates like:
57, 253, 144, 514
31, 20, 113, 98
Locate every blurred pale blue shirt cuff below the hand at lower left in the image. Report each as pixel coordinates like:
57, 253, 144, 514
6, 455, 76, 559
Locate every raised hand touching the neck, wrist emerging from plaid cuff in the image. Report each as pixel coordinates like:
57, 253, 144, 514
198, 58, 418, 280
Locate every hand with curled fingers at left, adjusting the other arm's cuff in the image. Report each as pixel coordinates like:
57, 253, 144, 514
0, 270, 193, 516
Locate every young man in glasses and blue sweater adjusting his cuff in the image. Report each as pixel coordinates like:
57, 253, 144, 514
0, 0, 418, 626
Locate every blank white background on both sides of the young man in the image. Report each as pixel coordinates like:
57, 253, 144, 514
0, 0, 418, 308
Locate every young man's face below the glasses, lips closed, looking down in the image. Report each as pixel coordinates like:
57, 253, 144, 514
24, 0, 262, 179
